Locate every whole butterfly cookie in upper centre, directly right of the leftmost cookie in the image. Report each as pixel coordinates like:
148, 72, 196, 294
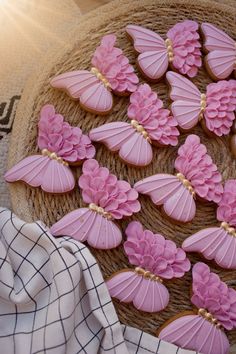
89, 84, 179, 166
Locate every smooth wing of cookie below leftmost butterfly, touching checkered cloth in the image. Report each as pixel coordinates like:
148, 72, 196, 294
50, 208, 122, 249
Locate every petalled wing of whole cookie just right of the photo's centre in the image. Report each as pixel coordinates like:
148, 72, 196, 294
175, 134, 223, 203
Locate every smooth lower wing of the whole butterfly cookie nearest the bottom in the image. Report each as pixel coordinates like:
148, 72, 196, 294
106, 270, 169, 312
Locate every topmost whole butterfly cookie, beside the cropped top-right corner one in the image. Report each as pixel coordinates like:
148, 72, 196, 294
126, 20, 202, 81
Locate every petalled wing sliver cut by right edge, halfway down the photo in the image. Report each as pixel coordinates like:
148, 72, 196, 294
217, 179, 236, 227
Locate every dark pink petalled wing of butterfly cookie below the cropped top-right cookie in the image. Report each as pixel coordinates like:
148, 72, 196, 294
204, 80, 236, 136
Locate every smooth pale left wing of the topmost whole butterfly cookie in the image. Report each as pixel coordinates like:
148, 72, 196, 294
126, 25, 169, 80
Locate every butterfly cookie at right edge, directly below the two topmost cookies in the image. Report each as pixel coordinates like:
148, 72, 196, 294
166, 71, 236, 136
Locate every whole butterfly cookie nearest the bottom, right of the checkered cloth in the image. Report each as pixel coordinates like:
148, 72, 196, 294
106, 221, 191, 312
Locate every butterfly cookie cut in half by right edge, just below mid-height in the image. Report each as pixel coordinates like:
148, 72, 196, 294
182, 179, 236, 269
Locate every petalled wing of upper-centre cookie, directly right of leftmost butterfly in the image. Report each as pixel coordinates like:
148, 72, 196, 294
128, 84, 179, 146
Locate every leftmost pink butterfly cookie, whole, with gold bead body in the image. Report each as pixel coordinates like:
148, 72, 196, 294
4, 104, 95, 193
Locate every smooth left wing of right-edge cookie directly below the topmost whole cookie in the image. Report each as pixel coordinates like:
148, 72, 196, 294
166, 71, 201, 130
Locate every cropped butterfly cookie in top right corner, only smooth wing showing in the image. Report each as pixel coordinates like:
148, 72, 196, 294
201, 23, 236, 80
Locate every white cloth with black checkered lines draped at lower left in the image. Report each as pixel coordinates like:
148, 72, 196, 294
0, 208, 195, 354
